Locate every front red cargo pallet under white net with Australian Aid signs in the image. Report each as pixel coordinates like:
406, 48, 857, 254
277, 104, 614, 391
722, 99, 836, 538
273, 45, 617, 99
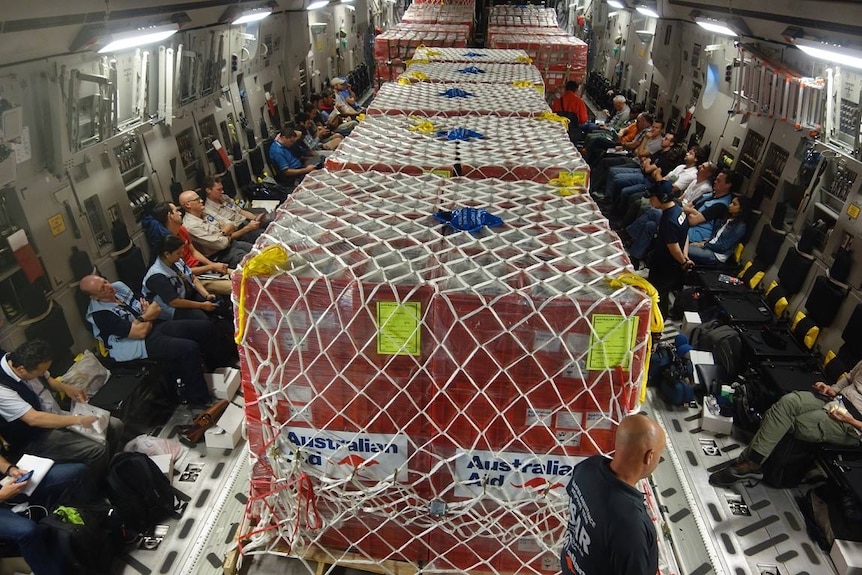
234, 172, 650, 574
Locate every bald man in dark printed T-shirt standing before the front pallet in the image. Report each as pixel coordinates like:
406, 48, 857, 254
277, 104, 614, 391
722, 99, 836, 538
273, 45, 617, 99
560, 414, 666, 575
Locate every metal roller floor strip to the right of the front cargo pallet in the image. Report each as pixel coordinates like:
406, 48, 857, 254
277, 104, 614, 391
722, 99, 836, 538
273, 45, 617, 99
644, 394, 837, 575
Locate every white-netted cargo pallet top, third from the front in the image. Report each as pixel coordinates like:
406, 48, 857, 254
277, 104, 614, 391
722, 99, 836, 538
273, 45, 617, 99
368, 82, 551, 116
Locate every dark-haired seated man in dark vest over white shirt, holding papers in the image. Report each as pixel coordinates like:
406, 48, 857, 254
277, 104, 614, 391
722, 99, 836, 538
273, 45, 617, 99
0, 339, 123, 481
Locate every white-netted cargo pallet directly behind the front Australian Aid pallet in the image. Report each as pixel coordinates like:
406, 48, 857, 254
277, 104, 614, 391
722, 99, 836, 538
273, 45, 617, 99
326, 112, 589, 187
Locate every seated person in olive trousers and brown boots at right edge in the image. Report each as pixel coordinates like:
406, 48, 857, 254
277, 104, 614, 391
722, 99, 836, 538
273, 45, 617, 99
709, 362, 862, 487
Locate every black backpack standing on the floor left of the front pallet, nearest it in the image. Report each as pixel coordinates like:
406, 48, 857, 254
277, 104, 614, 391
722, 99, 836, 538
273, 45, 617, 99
108, 452, 190, 533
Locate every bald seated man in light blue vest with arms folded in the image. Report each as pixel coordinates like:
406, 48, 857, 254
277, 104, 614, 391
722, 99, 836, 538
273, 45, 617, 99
80, 275, 212, 405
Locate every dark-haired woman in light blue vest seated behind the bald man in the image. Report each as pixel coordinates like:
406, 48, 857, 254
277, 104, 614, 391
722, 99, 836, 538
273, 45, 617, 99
143, 236, 218, 320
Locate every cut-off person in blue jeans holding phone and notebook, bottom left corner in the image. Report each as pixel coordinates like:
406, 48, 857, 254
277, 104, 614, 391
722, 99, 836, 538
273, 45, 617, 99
0, 456, 87, 575
